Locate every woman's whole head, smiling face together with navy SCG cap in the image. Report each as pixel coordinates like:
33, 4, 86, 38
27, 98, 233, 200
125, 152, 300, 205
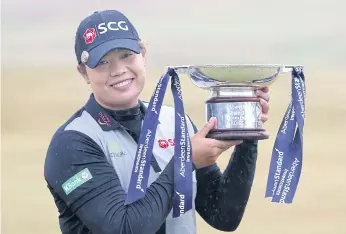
75, 12, 146, 109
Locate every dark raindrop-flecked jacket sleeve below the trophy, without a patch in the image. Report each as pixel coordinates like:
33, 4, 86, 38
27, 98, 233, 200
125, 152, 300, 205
195, 141, 257, 231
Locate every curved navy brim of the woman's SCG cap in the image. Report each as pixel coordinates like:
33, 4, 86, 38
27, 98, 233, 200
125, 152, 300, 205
86, 39, 140, 68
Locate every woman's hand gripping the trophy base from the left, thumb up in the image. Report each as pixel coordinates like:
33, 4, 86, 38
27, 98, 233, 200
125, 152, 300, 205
191, 117, 242, 169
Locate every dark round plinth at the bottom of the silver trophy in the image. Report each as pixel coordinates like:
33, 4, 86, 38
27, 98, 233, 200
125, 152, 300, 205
207, 129, 269, 141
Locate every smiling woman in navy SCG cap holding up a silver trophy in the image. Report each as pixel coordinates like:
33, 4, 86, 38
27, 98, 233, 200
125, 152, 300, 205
44, 10, 269, 234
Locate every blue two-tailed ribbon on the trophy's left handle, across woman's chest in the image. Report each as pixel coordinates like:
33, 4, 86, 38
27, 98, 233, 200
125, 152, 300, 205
125, 68, 193, 218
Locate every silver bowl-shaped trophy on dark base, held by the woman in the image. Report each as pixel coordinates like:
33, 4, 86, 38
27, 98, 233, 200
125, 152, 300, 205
170, 64, 293, 140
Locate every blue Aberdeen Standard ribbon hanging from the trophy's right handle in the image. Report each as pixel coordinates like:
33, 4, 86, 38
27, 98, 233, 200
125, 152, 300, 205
265, 67, 305, 203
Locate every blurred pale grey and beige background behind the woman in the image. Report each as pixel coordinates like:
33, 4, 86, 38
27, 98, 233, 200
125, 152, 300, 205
1, 0, 346, 234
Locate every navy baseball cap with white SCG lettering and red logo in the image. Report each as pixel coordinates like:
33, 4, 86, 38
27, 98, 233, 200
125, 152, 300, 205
75, 10, 140, 68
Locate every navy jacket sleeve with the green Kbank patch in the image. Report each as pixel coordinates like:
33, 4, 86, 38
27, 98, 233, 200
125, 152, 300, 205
44, 131, 173, 234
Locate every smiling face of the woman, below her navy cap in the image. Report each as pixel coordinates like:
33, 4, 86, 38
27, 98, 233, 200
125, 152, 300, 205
78, 46, 146, 109
